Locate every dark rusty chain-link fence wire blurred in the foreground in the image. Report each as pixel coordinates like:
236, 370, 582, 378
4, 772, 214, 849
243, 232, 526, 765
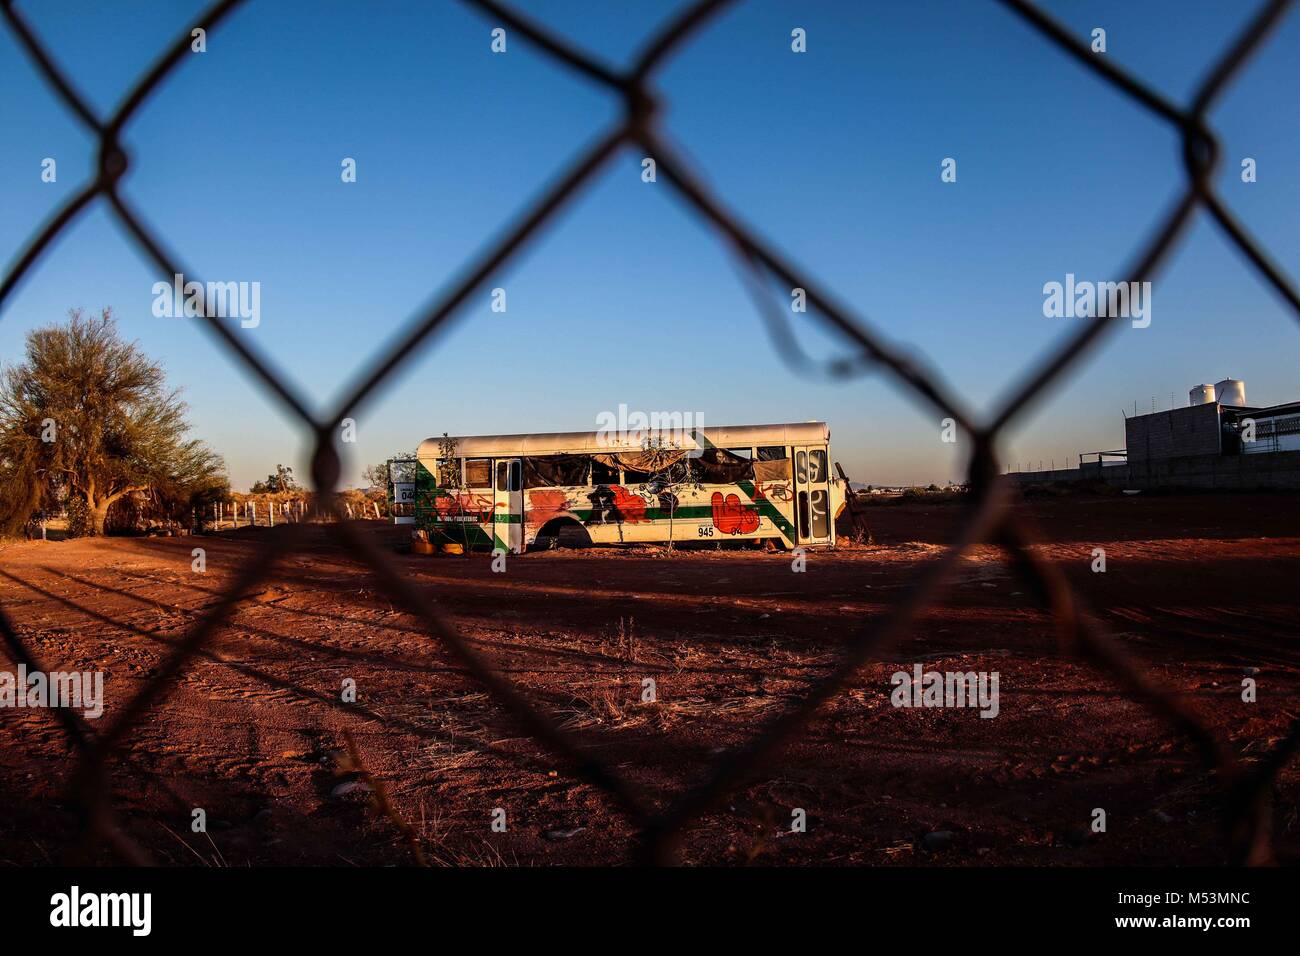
0, 0, 1300, 864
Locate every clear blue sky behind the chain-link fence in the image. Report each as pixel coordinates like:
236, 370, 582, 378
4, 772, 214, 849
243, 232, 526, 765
0, 0, 1300, 488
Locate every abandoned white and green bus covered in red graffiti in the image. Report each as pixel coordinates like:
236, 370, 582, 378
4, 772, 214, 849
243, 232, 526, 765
413, 421, 845, 554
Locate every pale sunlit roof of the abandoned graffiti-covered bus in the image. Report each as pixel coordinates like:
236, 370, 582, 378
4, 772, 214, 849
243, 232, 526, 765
416, 421, 831, 460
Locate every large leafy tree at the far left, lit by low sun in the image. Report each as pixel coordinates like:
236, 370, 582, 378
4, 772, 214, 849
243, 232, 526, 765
0, 308, 226, 535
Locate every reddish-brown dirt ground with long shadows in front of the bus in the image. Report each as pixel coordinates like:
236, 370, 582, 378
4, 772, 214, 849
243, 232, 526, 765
0, 494, 1300, 866
